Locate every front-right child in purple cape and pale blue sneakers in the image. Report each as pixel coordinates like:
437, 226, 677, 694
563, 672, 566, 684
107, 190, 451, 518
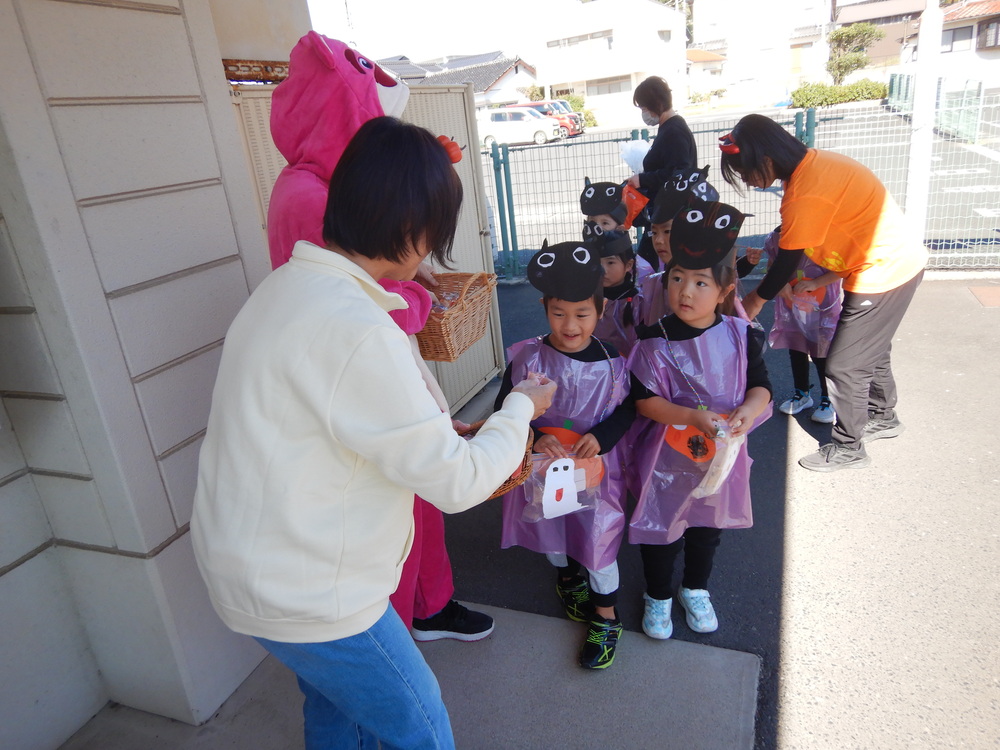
628, 201, 771, 639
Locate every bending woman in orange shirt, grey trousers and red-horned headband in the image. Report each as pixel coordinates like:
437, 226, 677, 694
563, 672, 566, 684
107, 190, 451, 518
719, 115, 927, 471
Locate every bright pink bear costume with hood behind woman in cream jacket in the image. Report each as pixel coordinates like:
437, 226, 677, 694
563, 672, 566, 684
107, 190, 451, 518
267, 31, 454, 627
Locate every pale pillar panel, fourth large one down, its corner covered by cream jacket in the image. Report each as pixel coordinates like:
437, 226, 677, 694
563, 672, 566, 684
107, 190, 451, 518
109, 262, 249, 378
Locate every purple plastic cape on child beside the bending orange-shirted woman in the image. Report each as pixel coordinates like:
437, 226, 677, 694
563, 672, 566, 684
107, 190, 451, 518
764, 232, 844, 357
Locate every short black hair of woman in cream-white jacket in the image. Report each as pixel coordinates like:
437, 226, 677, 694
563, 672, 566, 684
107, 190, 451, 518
323, 117, 462, 267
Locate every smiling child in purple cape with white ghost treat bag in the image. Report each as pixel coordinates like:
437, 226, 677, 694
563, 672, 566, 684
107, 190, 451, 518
497, 242, 635, 669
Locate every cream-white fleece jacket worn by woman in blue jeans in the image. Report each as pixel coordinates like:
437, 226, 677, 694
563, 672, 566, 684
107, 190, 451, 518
191, 242, 533, 643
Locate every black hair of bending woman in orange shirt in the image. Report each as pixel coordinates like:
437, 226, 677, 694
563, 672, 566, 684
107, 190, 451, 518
722, 115, 809, 190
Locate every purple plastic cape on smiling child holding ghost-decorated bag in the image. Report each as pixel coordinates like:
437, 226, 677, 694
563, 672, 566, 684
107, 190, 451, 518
500, 337, 629, 570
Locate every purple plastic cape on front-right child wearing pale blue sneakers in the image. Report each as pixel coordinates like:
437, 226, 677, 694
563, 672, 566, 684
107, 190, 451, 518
623, 316, 771, 544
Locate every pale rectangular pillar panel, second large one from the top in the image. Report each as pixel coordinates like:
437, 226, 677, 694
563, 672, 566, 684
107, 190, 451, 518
52, 103, 219, 200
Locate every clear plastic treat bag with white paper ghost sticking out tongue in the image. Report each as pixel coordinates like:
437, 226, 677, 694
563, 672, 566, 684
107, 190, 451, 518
522, 452, 604, 523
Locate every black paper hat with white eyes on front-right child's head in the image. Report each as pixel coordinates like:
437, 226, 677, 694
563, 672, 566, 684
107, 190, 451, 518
670, 196, 746, 271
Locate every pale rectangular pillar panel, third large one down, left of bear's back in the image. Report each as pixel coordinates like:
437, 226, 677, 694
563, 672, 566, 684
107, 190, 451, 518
80, 184, 237, 292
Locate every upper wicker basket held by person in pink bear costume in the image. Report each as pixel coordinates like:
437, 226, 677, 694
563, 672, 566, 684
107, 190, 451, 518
417, 272, 497, 362
